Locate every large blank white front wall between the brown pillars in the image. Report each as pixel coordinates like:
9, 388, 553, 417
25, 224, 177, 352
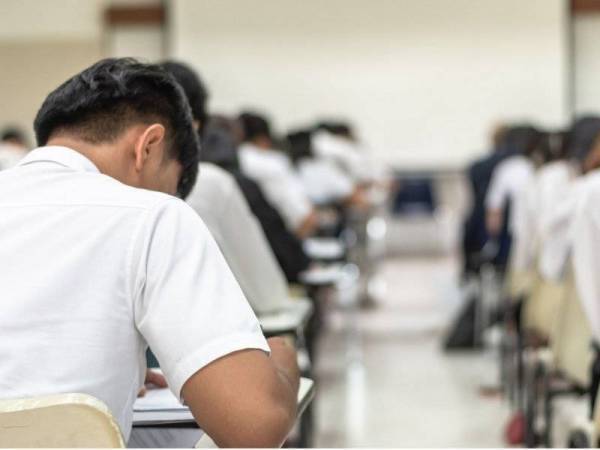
170, 0, 567, 167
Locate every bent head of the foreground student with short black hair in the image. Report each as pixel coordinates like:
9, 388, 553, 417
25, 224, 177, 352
34, 58, 199, 198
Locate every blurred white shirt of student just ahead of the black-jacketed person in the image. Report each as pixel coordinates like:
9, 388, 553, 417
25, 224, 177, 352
239, 143, 312, 231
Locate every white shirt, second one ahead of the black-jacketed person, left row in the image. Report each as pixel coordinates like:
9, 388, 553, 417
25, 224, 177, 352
298, 158, 354, 205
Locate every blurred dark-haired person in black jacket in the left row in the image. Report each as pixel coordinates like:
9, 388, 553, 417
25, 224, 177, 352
201, 117, 311, 283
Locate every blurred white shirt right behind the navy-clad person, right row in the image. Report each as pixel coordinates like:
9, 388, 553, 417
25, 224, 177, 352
486, 155, 535, 271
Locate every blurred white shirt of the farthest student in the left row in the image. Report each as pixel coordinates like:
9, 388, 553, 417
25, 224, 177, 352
311, 130, 375, 183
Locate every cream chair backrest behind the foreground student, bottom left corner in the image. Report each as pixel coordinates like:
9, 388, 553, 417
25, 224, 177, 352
0, 394, 125, 448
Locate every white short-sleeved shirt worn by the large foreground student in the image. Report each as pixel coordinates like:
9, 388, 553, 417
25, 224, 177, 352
0, 147, 268, 439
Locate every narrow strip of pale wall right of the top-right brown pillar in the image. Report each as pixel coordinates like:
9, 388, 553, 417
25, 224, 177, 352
573, 13, 600, 114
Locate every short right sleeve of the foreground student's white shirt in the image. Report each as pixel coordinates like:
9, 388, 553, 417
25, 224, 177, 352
132, 198, 269, 397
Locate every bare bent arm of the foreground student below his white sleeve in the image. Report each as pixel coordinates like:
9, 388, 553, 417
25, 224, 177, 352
182, 338, 299, 447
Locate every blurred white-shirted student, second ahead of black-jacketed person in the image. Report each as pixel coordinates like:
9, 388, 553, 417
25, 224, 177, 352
286, 130, 368, 208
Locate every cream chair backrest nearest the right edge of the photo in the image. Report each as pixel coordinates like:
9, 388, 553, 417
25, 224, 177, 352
552, 271, 593, 388
